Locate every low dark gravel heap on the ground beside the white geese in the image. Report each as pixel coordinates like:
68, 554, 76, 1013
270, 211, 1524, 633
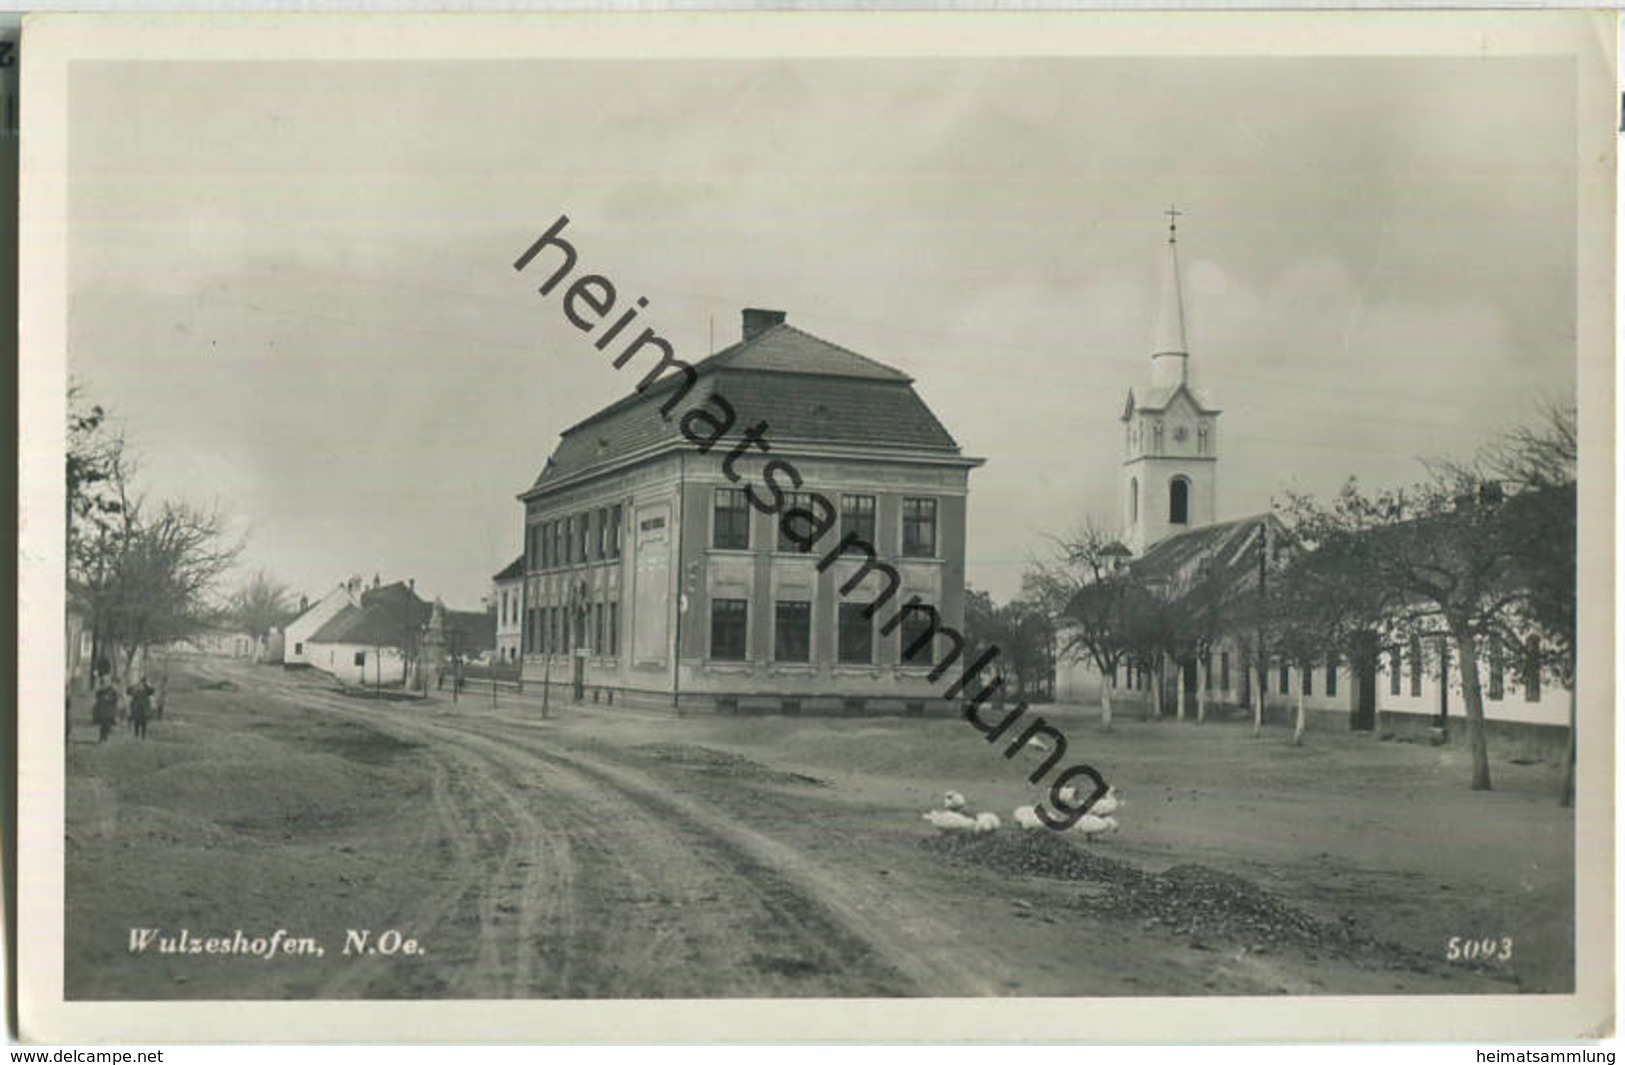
921, 832, 1420, 969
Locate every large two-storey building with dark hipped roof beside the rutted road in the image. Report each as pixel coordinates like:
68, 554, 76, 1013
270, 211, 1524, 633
520, 309, 982, 712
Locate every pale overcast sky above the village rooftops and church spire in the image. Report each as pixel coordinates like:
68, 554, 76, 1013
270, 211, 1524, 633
68, 59, 1576, 606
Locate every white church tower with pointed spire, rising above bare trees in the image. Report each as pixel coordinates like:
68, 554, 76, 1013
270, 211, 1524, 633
1118, 208, 1219, 556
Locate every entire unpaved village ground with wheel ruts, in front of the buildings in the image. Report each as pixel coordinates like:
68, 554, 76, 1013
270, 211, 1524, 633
67, 662, 1573, 998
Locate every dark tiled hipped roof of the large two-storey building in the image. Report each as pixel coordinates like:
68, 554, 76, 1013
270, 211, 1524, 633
525, 312, 972, 494
